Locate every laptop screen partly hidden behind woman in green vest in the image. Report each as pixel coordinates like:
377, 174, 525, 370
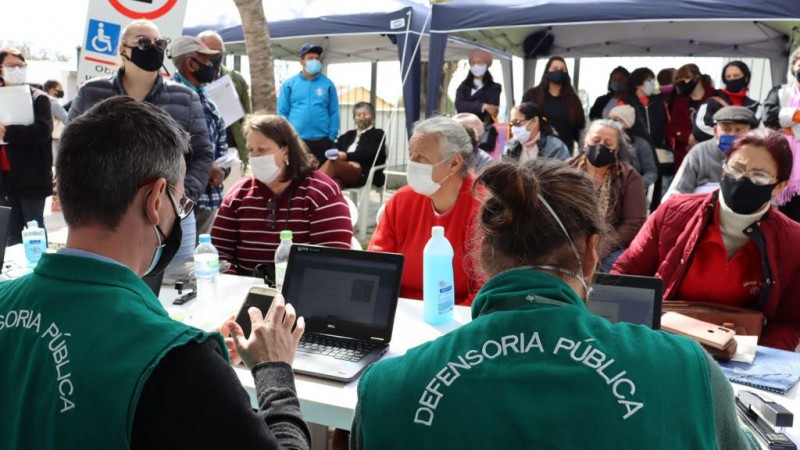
586, 273, 664, 330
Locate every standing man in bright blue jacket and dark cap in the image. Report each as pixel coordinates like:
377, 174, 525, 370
278, 44, 339, 165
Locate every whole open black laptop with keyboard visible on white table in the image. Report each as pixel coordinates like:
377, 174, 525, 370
282, 244, 404, 381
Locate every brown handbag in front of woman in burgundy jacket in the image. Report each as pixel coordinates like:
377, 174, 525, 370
661, 300, 764, 336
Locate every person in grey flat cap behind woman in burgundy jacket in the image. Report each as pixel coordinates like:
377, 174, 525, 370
664, 106, 756, 200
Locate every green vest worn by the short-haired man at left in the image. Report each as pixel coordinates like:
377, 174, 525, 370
0, 254, 225, 450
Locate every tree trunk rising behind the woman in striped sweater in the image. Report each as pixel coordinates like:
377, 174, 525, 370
233, 0, 278, 114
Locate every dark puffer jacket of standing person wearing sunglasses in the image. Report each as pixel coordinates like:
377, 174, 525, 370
69, 69, 214, 201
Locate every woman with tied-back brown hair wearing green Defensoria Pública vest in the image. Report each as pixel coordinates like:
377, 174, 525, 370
351, 159, 758, 449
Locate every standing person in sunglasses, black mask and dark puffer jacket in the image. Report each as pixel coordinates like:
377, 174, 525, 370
69, 20, 214, 276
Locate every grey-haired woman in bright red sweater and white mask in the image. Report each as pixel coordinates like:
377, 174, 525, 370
368, 117, 483, 305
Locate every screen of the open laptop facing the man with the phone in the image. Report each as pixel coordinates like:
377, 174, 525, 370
282, 245, 403, 338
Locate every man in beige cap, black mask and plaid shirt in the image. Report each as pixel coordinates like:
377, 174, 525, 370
169, 36, 230, 236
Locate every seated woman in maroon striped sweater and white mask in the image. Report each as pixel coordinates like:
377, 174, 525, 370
211, 113, 353, 276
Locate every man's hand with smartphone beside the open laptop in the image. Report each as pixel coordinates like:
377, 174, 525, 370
226, 294, 306, 368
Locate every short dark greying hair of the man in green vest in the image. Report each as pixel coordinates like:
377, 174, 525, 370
56, 96, 189, 230
